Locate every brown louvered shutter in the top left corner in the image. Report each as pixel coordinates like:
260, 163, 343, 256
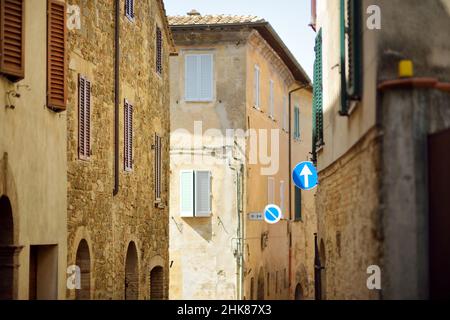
0, 0, 25, 81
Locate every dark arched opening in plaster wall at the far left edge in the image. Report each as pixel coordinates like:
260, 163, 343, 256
0, 196, 16, 300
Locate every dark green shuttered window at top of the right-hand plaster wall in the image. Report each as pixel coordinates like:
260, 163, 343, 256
340, 0, 362, 116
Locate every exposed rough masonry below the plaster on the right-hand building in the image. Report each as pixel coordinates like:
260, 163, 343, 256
316, 128, 382, 299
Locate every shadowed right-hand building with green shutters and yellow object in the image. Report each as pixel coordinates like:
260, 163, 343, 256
312, 0, 450, 299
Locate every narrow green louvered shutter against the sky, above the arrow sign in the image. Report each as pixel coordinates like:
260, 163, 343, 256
312, 30, 323, 160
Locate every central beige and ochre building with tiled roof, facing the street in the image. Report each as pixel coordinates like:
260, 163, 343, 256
169, 11, 315, 300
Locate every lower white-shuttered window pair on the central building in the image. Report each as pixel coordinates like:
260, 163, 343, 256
180, 170, 212, 217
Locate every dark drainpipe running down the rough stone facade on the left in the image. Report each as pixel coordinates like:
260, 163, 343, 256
113, 0, 120, 196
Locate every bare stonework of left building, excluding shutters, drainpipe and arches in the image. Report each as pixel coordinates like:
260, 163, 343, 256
67, 0, 170, 299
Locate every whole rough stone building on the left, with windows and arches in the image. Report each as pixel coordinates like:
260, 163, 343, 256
67, 0, 173, 299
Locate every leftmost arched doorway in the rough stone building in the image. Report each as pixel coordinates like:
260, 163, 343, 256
75, 239, 91, 300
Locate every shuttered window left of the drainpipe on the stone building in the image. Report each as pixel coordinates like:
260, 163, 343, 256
78, 74, 91, 160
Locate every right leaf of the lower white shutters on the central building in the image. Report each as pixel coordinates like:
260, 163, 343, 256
195, 171, 211, 217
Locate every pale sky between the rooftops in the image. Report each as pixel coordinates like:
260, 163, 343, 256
164, 0, 315, 79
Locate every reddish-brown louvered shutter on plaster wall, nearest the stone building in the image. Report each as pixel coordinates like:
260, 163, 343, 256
47, 0, 67, 111
